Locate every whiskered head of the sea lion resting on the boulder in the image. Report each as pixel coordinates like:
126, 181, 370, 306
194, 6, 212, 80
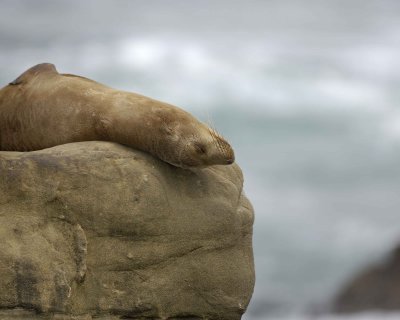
152, 110, 235, 168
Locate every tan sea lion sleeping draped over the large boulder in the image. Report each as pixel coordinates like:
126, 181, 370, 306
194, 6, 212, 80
0, 63, 234, 168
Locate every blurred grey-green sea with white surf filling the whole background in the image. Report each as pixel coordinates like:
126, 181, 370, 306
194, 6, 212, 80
0, 0, 400, 320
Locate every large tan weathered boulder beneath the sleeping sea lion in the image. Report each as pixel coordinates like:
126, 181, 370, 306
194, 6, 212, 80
0, 142, 254, 319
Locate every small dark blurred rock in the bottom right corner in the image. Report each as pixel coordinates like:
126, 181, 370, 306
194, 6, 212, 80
334, 247, 400, 313
